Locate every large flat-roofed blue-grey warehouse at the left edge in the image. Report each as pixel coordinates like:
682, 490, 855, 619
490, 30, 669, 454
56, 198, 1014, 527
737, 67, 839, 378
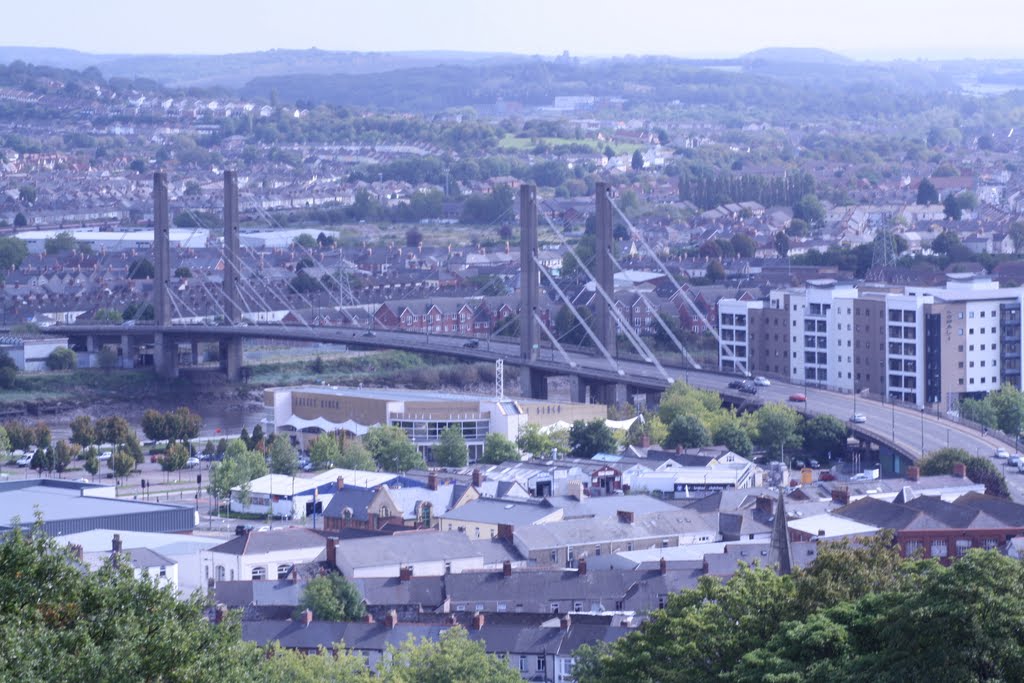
0, 479, 197, 536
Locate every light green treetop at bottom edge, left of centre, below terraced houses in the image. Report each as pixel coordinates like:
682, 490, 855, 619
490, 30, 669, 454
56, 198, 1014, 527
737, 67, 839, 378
379, 626, 522, 683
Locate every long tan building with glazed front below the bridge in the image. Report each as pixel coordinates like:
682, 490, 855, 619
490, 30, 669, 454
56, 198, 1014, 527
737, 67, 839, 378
264, 386, 607, 462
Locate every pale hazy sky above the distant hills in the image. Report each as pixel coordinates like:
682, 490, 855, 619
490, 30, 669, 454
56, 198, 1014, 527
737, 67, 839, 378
8, 0, 1024, 57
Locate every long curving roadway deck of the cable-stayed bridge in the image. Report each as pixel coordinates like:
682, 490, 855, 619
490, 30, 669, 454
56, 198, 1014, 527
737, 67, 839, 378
56, 325, 1024, 501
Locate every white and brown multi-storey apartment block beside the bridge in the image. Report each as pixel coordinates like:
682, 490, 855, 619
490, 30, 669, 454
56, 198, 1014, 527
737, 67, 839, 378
719, 274, 1024, 409
